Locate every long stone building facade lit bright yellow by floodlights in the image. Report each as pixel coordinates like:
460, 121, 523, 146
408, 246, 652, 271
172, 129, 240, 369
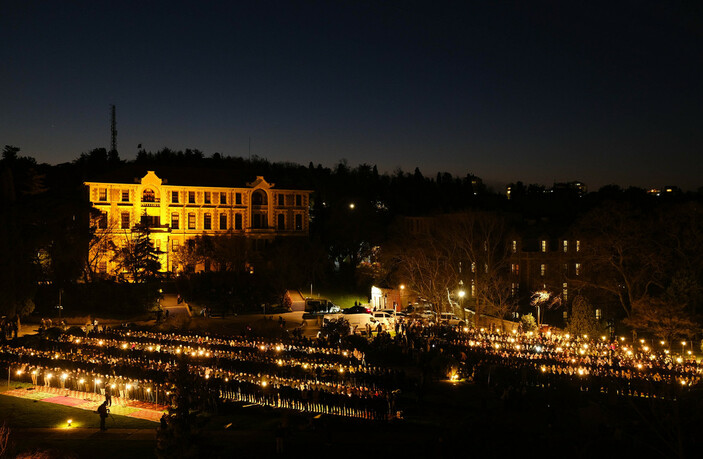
85, 171, 311, 275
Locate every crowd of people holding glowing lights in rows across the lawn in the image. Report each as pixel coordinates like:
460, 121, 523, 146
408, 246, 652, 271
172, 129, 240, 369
0, 320, 703, 419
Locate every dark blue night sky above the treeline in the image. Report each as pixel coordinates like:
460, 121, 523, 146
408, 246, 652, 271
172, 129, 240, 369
0, 0, 703, 189
